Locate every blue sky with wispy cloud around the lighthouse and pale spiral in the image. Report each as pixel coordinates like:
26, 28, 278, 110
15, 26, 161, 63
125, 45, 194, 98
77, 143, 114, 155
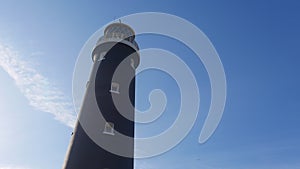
0, 0, 300, 169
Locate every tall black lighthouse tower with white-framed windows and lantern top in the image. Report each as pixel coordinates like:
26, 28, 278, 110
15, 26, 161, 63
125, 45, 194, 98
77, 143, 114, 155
63, 23, 139, 169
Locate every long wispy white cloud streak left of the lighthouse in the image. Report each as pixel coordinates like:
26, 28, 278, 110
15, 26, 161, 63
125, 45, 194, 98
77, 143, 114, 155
0, 44, 76, 127
